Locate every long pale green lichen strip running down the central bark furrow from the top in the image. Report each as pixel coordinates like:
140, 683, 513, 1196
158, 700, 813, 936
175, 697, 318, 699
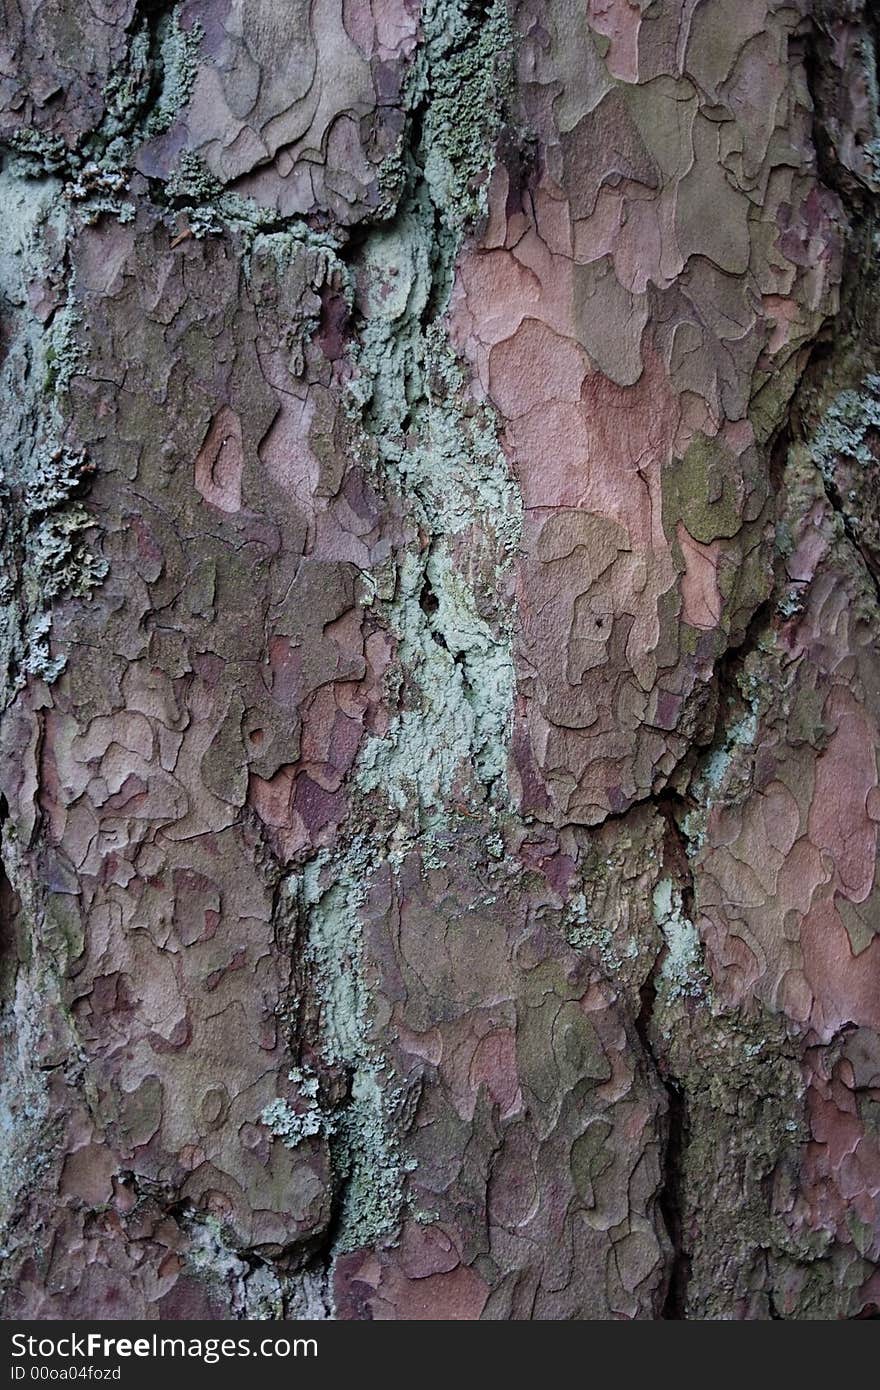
261, 0, 521, 1278
